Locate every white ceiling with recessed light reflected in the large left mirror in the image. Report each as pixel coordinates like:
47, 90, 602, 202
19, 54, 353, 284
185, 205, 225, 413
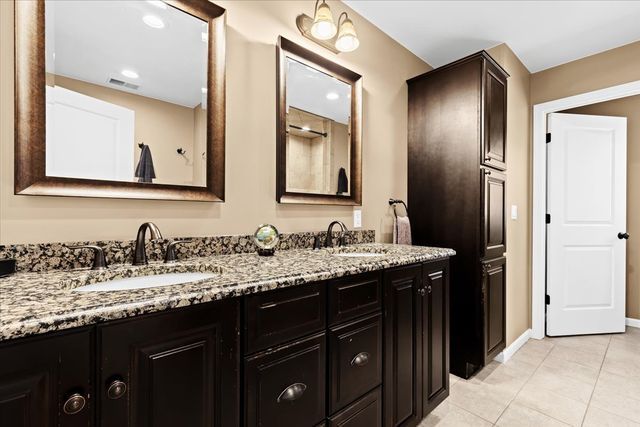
45, 0, 208, 108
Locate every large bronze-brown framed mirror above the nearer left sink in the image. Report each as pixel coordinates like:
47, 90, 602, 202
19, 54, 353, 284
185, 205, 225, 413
14, 0, 225, 201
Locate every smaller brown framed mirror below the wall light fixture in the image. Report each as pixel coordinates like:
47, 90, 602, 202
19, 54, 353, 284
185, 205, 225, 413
276, 37, 362, 205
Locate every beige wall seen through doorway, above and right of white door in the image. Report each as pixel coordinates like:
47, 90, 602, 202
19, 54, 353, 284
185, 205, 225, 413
563, 95, 640, 319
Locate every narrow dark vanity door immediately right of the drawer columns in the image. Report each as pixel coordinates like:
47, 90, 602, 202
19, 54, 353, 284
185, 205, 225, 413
384, 265, 422, 427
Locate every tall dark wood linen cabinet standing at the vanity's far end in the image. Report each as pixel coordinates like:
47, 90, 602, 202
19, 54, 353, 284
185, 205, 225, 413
408, 51, 508, 378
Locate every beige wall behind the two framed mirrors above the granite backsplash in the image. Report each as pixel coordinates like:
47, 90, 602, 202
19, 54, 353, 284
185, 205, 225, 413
0, 1, 430, 244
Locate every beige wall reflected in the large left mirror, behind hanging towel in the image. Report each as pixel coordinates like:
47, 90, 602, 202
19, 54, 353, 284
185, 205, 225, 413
47, 76, 206, 185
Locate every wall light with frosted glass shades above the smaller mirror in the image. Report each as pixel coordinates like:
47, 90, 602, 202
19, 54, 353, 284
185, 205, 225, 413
296, 0, 360, 53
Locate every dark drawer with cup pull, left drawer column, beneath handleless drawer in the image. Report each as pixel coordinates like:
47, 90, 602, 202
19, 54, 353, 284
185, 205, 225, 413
245, 333, 326, 427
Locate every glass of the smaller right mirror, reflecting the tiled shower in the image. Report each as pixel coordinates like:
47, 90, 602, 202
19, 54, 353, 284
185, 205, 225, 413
286, 57, 351, 196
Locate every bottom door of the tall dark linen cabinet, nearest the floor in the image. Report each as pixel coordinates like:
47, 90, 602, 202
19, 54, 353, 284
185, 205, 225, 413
482, 258, 507, 364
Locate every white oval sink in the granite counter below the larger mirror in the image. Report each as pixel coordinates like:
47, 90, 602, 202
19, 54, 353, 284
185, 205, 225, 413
73, 272, 218, 292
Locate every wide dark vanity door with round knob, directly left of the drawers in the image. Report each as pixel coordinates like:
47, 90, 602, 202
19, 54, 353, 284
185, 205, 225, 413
98, 299, 239, 427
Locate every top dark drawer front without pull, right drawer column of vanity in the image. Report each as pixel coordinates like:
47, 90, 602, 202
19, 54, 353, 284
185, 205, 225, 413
328, 272, 382, 325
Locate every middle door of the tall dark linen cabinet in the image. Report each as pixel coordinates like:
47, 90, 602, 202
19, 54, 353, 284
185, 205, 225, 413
482, 169, 507, 258
